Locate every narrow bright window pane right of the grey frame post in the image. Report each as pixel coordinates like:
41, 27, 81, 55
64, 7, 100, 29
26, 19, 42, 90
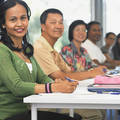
106, 0, 120, 34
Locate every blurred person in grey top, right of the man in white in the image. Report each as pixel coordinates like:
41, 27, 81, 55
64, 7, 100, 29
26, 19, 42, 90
101, 32, 120, 66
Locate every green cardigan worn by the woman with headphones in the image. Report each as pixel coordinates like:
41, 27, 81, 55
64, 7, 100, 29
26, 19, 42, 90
0, 43, 52, 120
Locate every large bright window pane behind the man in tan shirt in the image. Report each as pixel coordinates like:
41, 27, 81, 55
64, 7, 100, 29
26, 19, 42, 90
26, 0, 91, 51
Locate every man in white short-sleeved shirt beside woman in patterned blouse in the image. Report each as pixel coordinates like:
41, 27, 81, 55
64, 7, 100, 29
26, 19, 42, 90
81, 21, 115, 68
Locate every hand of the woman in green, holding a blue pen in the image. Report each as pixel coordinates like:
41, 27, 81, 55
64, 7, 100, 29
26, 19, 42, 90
51, 79, 78, 93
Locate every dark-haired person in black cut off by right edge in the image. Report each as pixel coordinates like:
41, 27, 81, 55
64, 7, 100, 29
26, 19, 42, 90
112, 33, 120, 60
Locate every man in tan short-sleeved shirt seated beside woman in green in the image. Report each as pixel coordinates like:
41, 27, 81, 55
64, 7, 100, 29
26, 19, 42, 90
34, 8, 104, 120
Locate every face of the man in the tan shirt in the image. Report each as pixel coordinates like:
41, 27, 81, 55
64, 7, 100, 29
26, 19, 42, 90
41, 13, 64, 40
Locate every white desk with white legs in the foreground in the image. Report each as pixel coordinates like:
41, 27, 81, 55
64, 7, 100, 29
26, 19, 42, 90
24, 80, 120, 120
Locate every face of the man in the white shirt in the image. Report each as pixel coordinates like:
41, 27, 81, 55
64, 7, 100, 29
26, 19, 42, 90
88, 24, 102, 44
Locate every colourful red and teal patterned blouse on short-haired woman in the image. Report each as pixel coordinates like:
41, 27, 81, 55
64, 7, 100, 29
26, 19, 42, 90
60, 42, 92, 72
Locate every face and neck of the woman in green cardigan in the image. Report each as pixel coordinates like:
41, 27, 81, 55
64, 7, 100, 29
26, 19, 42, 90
3, 4, 28, 48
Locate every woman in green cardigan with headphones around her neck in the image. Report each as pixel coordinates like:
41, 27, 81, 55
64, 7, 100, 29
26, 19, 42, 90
0, 0, 78, 120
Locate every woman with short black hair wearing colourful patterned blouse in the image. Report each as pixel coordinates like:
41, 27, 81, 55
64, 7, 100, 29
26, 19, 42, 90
60, 20, 96, 72
